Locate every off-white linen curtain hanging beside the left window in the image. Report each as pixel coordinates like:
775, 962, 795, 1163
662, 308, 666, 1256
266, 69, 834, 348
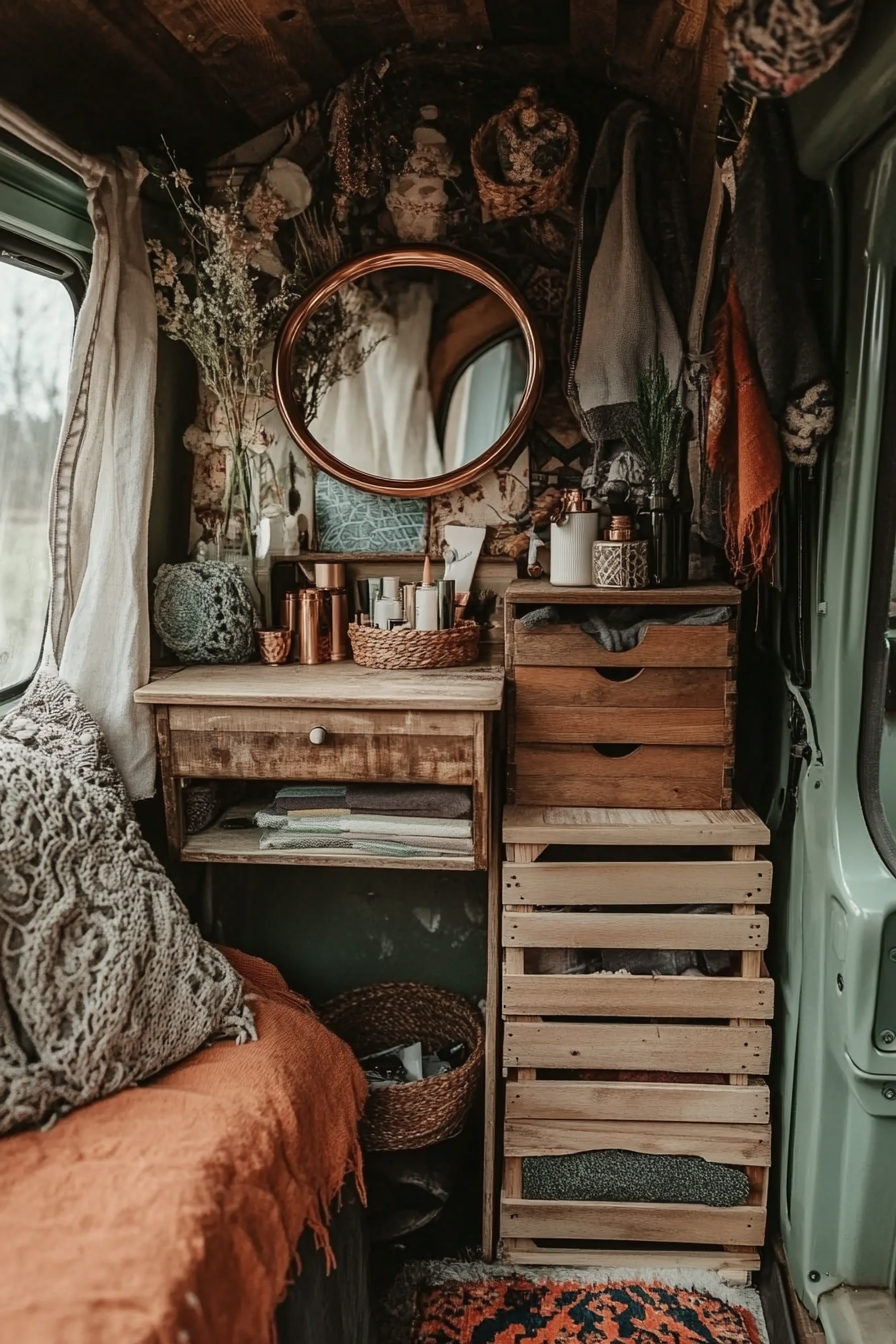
0, 102, 157, 798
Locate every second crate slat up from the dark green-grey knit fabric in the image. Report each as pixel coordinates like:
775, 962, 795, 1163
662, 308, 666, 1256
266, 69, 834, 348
505, 1079, 770, 1125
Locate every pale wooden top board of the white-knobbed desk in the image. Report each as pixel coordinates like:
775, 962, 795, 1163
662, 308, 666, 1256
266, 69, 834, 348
134, 663, 504, 712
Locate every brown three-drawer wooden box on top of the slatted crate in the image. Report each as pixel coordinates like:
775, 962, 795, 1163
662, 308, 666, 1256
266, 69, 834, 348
505, 582, 739, 809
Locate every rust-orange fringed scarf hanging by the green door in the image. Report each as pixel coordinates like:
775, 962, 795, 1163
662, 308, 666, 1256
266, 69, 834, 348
707, 274, 782, 585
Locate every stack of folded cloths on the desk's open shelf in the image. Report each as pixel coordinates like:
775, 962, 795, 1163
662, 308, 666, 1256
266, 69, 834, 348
255, 784, 473, 859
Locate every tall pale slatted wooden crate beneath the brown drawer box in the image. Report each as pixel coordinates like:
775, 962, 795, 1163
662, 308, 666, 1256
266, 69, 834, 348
500, 806, 774, 1277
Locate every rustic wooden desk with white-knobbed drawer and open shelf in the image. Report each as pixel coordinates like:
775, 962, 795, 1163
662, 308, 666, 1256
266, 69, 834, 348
136, 663, 504, 871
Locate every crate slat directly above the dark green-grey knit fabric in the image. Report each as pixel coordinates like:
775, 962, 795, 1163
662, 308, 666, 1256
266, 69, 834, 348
504, 1112, 771, 1167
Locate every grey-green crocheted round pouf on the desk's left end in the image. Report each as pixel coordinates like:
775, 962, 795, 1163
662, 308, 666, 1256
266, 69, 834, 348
153, 560, 255, 663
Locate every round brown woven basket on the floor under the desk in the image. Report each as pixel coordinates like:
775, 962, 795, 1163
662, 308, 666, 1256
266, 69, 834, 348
320, 981, 485, 1153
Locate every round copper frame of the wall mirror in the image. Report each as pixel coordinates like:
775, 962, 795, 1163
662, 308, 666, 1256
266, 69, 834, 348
273, 246, 544, 499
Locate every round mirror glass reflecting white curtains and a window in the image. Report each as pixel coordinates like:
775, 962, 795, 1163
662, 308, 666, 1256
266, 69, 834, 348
293, 267, 528, 481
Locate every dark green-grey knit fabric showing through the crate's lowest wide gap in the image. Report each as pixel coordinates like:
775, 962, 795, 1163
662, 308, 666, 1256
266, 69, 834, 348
523, 1148, 750, 1208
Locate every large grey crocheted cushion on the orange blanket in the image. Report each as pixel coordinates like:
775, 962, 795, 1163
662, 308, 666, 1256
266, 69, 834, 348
0, 676, 254, 1133
